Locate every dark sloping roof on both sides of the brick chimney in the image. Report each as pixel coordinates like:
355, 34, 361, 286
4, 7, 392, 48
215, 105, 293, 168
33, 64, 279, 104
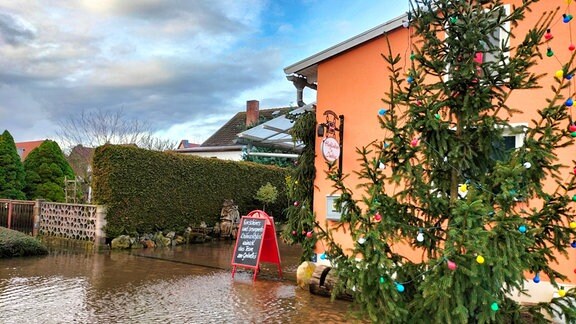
198, 107, 294, 150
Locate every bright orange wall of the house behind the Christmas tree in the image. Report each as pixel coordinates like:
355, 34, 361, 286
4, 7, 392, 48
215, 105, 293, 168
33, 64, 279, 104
314, 0, 576, 283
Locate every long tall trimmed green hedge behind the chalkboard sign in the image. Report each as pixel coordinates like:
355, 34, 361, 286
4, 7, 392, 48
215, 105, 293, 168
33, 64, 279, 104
92, 145, 288, 237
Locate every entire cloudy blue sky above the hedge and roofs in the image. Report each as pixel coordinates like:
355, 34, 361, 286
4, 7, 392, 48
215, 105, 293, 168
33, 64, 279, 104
0, 0, 408, 143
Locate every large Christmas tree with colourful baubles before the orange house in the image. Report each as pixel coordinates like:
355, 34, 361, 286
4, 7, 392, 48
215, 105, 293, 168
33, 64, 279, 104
317, 0, 576, 323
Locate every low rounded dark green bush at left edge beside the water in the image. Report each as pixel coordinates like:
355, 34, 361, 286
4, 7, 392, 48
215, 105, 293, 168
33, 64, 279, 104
0, 227, 48, 258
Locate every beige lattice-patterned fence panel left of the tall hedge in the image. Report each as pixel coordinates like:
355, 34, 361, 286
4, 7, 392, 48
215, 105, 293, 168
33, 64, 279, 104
39, 202, 96, 241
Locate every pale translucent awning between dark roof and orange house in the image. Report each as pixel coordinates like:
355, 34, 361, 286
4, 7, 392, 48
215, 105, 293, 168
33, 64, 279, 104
237, 104, 314, 152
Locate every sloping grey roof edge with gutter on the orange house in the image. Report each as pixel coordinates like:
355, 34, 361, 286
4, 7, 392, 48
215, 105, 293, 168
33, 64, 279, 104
284, 14, 408, 83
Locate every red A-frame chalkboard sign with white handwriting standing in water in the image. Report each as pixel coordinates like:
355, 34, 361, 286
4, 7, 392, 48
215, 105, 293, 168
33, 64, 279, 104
232, 210, 282, 280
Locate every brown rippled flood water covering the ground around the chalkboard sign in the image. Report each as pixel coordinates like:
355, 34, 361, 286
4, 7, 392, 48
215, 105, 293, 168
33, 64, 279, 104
0, 242, 352, 323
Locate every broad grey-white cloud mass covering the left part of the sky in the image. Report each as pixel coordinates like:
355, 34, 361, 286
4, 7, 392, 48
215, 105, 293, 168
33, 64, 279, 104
0, 0, 291, 144
